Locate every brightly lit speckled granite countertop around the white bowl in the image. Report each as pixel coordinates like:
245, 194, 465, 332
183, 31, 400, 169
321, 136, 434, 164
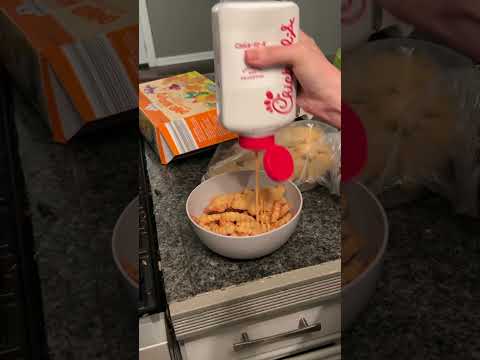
146, 143, 341, 303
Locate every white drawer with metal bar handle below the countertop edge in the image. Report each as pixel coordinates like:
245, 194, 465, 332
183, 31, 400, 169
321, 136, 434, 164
182, 298, 341, 360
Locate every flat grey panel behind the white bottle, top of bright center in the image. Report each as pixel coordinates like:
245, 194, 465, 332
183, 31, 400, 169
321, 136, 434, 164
146, 0, 341, 65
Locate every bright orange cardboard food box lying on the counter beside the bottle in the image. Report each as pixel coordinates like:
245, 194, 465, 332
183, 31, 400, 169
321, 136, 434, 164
139, 71, 236, 164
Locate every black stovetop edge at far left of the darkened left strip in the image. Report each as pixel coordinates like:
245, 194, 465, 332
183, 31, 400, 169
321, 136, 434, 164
0, 67, 47, 359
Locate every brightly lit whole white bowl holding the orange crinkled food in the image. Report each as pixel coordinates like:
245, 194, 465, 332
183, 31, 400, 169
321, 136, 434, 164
186, 171, 303, 259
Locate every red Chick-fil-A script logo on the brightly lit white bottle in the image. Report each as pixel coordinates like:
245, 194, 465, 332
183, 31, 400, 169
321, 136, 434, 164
264, 18, 297, 115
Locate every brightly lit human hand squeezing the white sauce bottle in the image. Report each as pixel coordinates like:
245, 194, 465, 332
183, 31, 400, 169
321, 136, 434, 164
245, 32, 342, 129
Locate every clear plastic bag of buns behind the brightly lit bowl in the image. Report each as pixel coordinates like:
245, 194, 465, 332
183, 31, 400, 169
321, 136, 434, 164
203, 119, 341, 194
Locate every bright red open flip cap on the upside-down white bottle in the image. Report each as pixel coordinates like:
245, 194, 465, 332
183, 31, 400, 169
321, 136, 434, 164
238, 135, 293, 182
